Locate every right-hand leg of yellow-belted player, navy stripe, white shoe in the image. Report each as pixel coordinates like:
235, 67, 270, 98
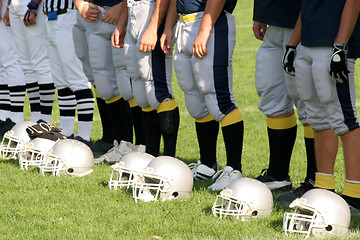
192, 14, 244, 191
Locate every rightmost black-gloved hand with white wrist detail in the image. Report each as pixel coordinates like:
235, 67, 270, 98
330, 44, 349, 83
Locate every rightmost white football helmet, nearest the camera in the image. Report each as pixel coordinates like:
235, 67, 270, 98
283, 189, 351, 237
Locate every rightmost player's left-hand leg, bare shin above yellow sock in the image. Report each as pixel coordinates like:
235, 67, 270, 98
295, 47, 340, 192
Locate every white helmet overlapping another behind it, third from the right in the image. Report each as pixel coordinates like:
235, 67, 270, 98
133, 156, 193, 202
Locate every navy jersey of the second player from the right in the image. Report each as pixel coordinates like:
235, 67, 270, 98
253, 0, 301, 28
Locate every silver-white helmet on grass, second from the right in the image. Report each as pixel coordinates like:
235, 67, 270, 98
212, 178, 274, 220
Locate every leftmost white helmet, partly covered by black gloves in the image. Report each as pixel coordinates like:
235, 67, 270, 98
0, 121, 36, 159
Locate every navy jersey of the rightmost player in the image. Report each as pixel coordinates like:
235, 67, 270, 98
301, 0, 345, 47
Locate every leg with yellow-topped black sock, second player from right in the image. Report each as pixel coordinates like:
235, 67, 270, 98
255, 26, 297, 190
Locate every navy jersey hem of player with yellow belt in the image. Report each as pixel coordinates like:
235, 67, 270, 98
176, 0, 237, 14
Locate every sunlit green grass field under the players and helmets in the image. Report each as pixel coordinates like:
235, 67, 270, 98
0, 0, 360, 239
